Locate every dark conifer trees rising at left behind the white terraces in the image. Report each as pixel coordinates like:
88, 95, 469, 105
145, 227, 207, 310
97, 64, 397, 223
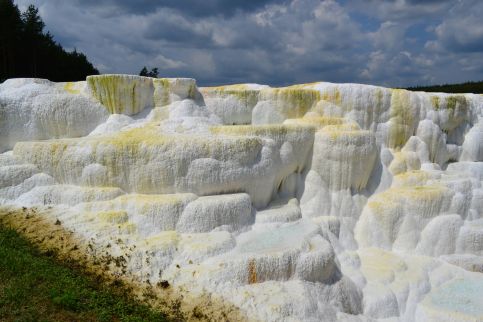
0, 0, 99, 82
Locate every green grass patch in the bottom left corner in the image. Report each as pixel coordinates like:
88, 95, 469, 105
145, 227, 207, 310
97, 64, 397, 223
0, 226, 167, 321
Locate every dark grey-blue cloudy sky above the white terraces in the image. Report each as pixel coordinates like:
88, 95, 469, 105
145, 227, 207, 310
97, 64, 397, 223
16, 0, 483, 87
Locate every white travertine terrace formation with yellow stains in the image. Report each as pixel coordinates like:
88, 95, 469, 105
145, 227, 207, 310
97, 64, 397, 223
0, 75, 483, 321
